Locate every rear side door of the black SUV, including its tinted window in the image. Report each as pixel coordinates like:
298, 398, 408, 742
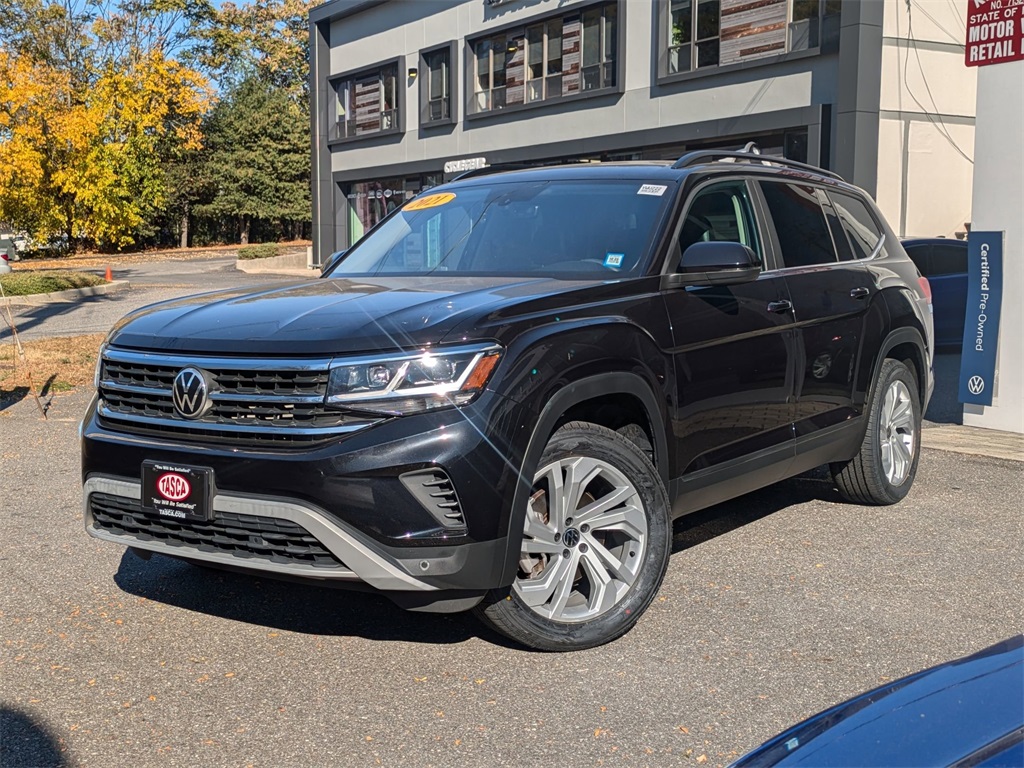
759, 180, 876, 441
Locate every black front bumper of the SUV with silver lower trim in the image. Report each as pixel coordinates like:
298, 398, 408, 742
82, 394, 521, 593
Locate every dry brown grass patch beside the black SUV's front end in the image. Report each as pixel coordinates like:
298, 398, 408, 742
0, 334, 105, 408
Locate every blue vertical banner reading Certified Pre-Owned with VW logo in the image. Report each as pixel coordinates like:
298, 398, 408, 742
959, 231, 1002, 406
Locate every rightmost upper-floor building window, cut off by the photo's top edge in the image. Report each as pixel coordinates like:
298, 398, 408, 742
658, 0, 840, 78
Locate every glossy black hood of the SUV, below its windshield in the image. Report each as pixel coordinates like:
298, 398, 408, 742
110, 278, 594, 355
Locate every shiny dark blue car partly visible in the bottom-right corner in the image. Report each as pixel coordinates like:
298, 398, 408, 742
732, 635, 1024, 768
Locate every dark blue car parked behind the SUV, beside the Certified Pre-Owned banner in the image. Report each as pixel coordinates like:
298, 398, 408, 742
903, 238, 967, 347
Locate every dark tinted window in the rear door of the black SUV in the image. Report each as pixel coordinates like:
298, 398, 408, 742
761, 181, 838, 266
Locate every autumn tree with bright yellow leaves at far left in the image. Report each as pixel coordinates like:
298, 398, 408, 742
0, 0, 211, 248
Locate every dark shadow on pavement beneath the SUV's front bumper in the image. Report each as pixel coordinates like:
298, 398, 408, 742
114, 550, 520, 652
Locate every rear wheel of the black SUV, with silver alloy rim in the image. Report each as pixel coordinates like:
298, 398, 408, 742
829, 359, 921, 506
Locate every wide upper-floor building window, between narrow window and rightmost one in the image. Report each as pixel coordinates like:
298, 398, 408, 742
469, 2, 620, 114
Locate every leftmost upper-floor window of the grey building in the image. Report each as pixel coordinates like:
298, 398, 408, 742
331, 61, 401, 139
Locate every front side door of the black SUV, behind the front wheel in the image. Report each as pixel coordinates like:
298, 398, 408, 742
664, 178, 795, 512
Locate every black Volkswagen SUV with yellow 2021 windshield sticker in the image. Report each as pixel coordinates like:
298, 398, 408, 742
82, 152, 933, 650
